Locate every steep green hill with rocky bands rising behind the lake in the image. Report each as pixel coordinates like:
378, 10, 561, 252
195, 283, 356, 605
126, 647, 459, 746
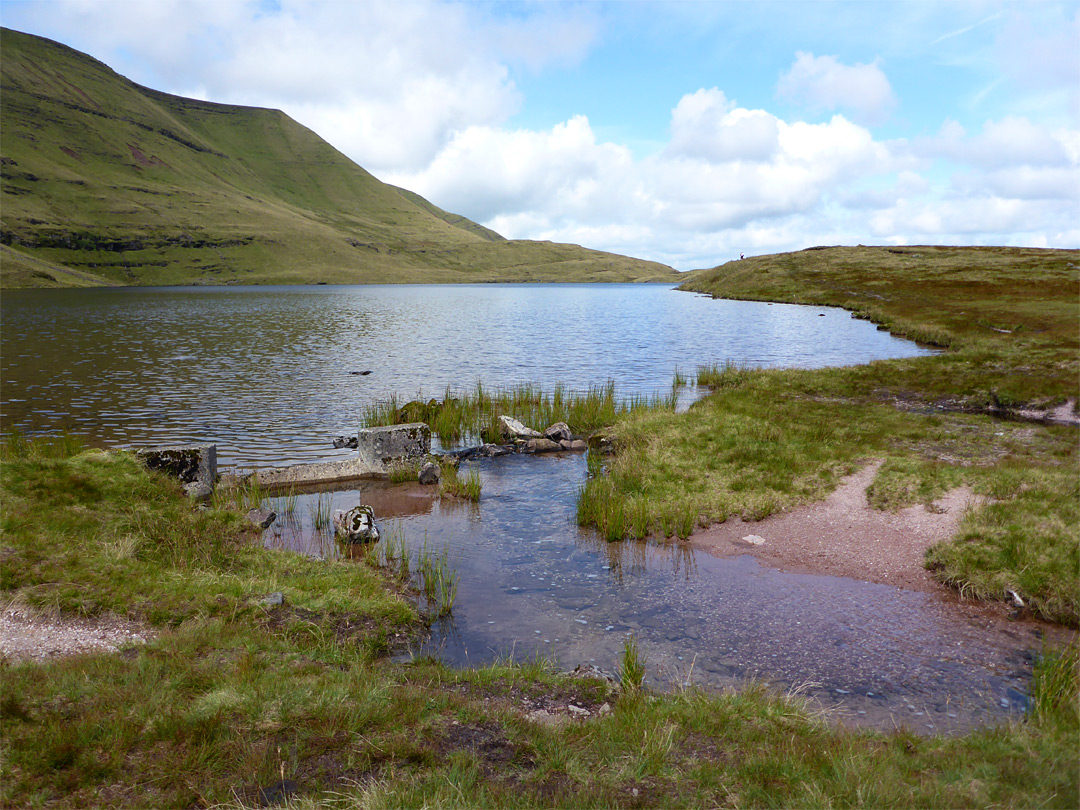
0, 29, 678, 288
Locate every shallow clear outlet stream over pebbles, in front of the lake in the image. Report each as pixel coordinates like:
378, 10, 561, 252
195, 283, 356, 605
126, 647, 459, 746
266, 454, 1071, 733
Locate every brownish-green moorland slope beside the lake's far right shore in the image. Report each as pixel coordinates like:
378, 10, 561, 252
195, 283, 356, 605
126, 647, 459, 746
681, 240, 1080, 409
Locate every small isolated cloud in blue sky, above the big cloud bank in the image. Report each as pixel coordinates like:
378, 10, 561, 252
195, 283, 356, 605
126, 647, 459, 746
777, 51, 896, 124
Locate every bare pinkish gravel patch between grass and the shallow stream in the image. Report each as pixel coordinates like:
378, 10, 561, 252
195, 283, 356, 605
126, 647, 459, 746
690, 461, 974, 591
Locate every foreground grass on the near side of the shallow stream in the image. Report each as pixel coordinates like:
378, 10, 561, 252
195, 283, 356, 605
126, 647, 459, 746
0, 443, 1080, 808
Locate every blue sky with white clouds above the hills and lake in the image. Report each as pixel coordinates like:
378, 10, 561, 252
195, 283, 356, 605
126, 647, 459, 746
6, 0, 1080, 270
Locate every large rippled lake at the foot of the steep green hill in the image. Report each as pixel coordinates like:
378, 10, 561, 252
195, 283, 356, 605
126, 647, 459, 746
0, 284, 923, 467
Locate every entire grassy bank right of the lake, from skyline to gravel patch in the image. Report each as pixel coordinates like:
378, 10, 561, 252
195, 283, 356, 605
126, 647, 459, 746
579, 247, 1080, 625
